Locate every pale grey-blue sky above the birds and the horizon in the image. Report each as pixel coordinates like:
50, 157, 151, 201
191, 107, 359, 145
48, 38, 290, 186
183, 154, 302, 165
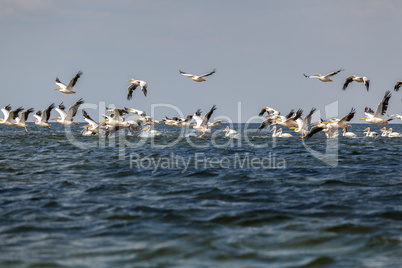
0, 0, 402, 123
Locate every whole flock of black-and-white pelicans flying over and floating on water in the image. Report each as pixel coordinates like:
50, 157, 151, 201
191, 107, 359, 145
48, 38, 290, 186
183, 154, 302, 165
0, 69, 402, 139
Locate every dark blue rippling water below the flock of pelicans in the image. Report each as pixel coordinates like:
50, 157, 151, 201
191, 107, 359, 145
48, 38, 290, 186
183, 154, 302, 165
0, 124, 402, 267
